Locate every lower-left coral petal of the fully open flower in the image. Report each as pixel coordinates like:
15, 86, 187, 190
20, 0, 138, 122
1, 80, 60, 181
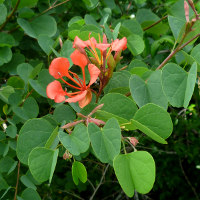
46, 80, 66, 103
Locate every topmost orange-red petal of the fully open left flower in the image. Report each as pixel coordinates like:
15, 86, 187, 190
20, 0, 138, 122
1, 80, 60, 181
70, 49, 88, 68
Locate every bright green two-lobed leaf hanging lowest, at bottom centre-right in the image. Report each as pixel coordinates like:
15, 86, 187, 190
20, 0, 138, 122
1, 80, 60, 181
113, 151, 155, 197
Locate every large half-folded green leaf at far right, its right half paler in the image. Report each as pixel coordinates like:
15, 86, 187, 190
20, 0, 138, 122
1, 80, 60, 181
162, 63, 197, 108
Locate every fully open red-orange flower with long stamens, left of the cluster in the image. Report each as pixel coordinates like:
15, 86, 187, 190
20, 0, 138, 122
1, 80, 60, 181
46, 50, 100, 108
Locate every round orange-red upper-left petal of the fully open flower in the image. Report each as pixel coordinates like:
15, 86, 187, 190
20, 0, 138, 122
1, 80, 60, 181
49, 57, 70, 79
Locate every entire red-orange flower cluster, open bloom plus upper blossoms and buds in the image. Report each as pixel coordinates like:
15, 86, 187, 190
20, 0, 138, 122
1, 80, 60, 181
46, 35, 127, 108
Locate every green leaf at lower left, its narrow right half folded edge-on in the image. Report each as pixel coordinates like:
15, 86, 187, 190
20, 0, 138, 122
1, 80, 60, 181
28, 147, 58, 183
